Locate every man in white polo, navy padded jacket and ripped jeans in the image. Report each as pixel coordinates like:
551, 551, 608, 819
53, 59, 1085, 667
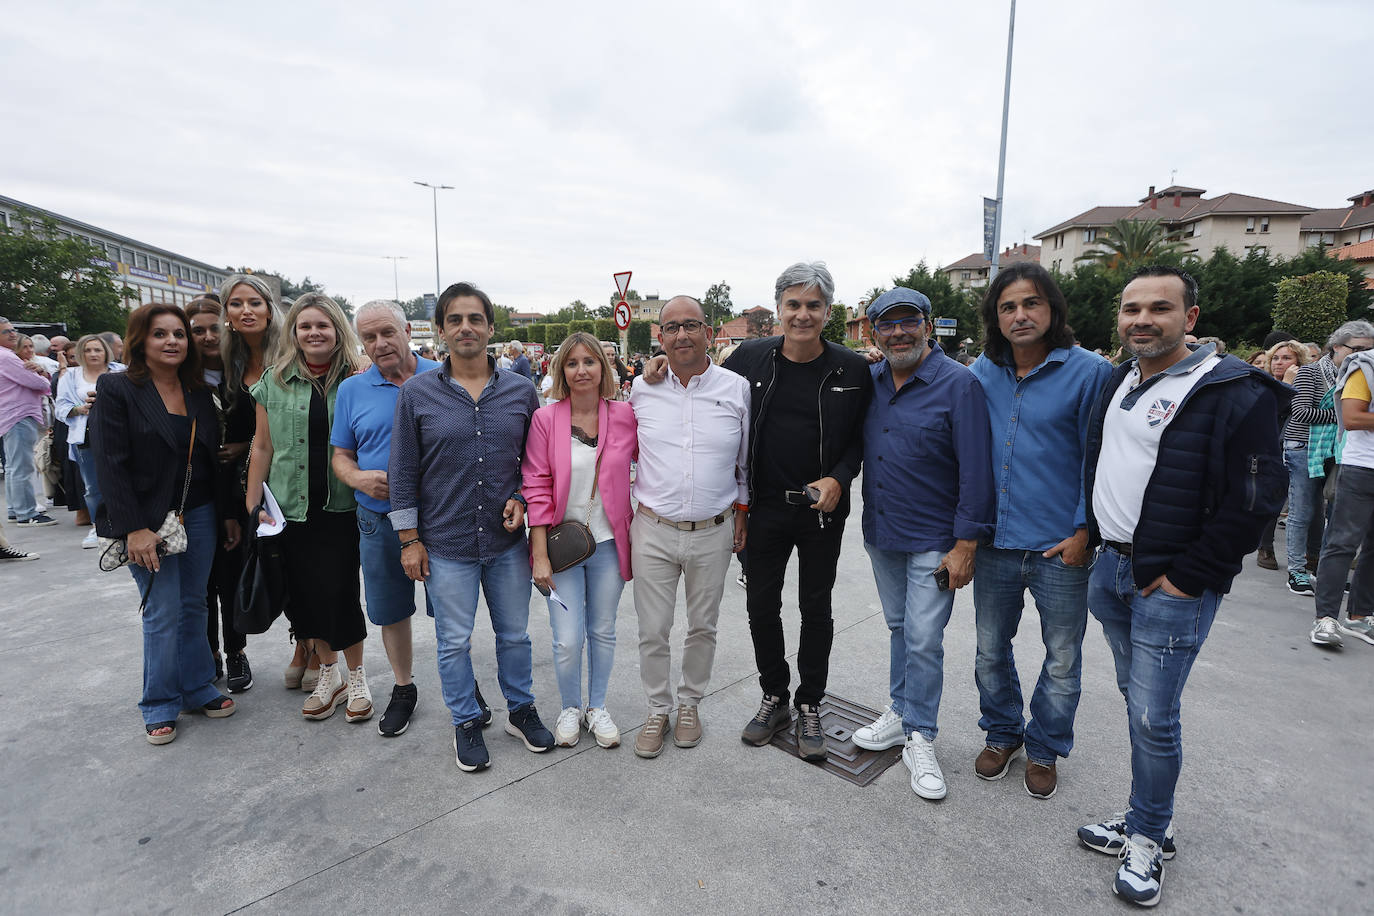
1079, 266, 1292, 906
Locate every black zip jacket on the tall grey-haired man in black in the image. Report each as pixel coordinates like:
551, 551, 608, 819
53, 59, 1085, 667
724, 336, 872, 518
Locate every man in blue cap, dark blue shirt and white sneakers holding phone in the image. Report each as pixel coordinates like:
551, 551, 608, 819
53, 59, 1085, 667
853, 287, 996, 801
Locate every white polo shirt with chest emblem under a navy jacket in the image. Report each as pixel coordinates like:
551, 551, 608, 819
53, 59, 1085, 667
1092, 343, 1221, 544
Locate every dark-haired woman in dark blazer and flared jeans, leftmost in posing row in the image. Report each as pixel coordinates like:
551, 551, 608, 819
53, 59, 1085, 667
87, 302, 239, 744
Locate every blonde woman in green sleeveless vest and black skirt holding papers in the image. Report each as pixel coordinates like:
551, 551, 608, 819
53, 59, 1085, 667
245, 293, 372, 722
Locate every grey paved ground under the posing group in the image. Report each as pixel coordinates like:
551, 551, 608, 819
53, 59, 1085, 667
0, 502, 1374, 913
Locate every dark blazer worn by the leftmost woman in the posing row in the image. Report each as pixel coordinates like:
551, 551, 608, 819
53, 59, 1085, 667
88, 372, 234, 537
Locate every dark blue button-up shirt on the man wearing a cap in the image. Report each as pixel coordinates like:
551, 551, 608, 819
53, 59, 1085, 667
863, 345, 996, 553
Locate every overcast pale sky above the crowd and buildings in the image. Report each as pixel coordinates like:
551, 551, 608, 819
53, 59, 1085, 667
0, 0, 1374, 310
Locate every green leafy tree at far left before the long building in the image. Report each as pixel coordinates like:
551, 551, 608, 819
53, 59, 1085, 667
0, 214, 131, 339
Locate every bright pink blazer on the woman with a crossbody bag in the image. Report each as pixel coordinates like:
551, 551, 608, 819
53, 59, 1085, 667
521, 398, 639, 581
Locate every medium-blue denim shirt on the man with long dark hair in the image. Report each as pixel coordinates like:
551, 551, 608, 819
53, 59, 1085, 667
970, 346, 1112, 551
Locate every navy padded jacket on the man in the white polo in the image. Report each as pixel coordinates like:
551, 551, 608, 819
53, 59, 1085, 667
1084, 348, 1293, 595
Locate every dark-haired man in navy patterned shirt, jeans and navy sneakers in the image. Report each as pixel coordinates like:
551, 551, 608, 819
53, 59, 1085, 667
387, 283, 554, 772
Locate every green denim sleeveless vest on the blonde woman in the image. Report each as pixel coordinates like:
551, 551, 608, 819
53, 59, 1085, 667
249, 367, 357, 522
